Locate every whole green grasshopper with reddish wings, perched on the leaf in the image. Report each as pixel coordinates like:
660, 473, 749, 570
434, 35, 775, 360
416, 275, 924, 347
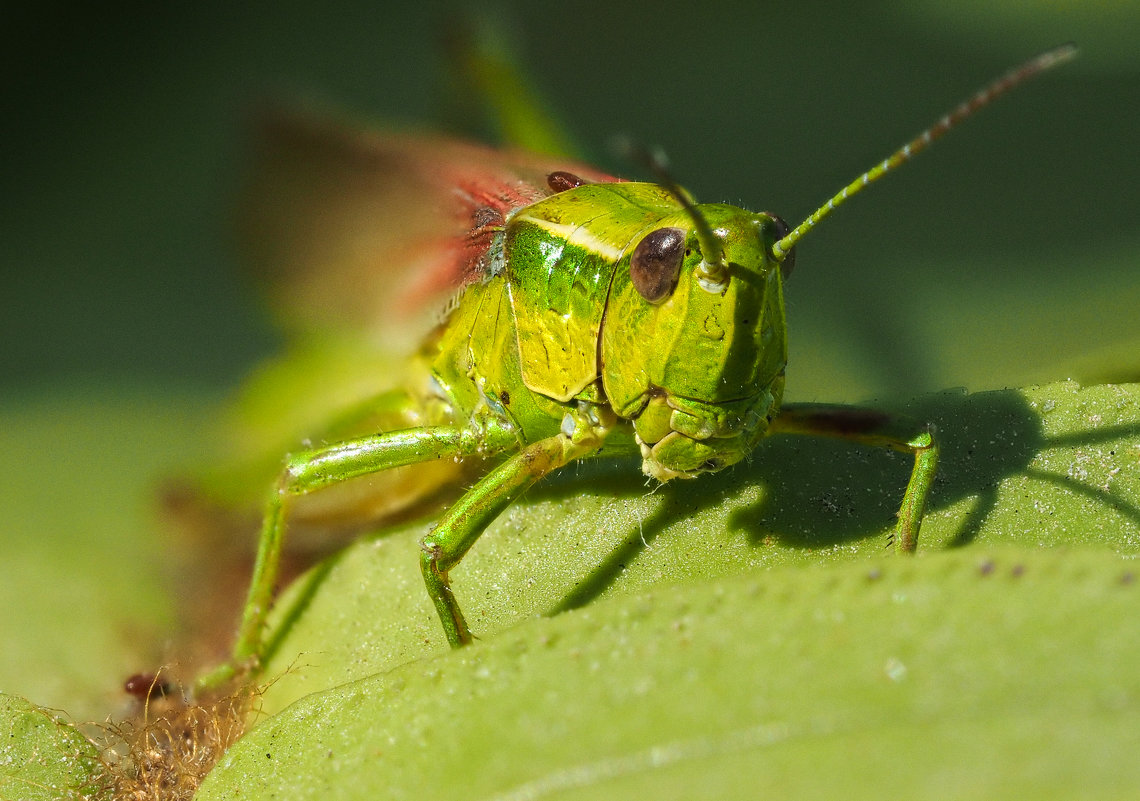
200, 46, 1075, 686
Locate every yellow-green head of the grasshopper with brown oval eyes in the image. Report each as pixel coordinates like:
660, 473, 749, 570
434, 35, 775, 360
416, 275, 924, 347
601, 204, 790, 481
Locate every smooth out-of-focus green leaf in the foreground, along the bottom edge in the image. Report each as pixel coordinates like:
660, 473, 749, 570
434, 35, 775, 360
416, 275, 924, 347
198, 549, 1140, 799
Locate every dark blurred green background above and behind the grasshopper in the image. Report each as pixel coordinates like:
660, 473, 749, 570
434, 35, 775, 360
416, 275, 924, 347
0, 0, 1140, 400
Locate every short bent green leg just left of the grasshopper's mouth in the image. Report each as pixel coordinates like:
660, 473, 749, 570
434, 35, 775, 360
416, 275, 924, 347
420, 408, 610, 647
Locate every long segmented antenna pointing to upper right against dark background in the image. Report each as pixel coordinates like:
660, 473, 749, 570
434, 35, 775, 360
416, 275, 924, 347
772, 43, 1076, 262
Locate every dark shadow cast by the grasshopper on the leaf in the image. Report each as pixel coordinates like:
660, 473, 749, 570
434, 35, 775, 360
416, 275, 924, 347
536, 390, 1140, 613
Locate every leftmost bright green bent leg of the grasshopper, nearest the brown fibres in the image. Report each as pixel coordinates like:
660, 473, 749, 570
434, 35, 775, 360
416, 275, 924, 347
197, 422, 519, 688
